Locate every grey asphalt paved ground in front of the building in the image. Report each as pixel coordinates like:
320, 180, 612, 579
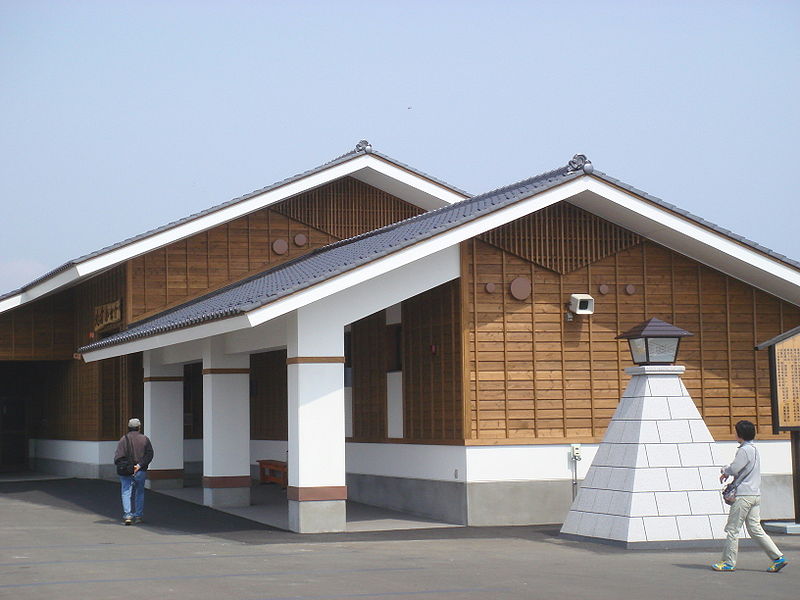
0, 479, 800, 600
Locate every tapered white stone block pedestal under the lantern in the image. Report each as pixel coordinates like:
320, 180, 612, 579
561, 365, 728, 548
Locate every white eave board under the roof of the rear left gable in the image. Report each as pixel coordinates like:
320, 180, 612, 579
0, 154, 468, 313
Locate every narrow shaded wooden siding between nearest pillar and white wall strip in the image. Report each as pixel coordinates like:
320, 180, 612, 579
350, 310, 388, 442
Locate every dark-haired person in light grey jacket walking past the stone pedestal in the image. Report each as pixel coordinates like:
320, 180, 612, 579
711, 421, 787, 573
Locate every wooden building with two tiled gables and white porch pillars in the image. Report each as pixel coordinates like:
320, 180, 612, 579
0, 143, 800, 531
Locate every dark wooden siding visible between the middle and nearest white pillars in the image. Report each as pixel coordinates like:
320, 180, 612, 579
250, 350, 289, 440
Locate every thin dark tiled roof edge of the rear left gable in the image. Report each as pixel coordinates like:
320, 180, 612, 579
0, 142, 472, 300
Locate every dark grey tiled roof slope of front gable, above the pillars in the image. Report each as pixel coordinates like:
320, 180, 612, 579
79, 162, 583, 352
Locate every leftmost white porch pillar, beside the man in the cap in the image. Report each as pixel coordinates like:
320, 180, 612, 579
143, 351, 183, 489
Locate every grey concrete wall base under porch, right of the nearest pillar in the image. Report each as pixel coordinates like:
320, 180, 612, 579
347, 473, 467, 525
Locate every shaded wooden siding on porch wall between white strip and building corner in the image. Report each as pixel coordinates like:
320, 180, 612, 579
402, 280, 464, 443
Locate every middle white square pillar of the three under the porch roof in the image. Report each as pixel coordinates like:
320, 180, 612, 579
203, 339, 251, 507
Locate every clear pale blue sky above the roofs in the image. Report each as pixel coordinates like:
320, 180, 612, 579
0, 0, 800, 292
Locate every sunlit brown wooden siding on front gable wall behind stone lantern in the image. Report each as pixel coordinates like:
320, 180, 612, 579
461, 227, 800, 444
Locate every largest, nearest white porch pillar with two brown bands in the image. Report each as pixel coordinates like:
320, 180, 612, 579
287, 309, 347, 533
